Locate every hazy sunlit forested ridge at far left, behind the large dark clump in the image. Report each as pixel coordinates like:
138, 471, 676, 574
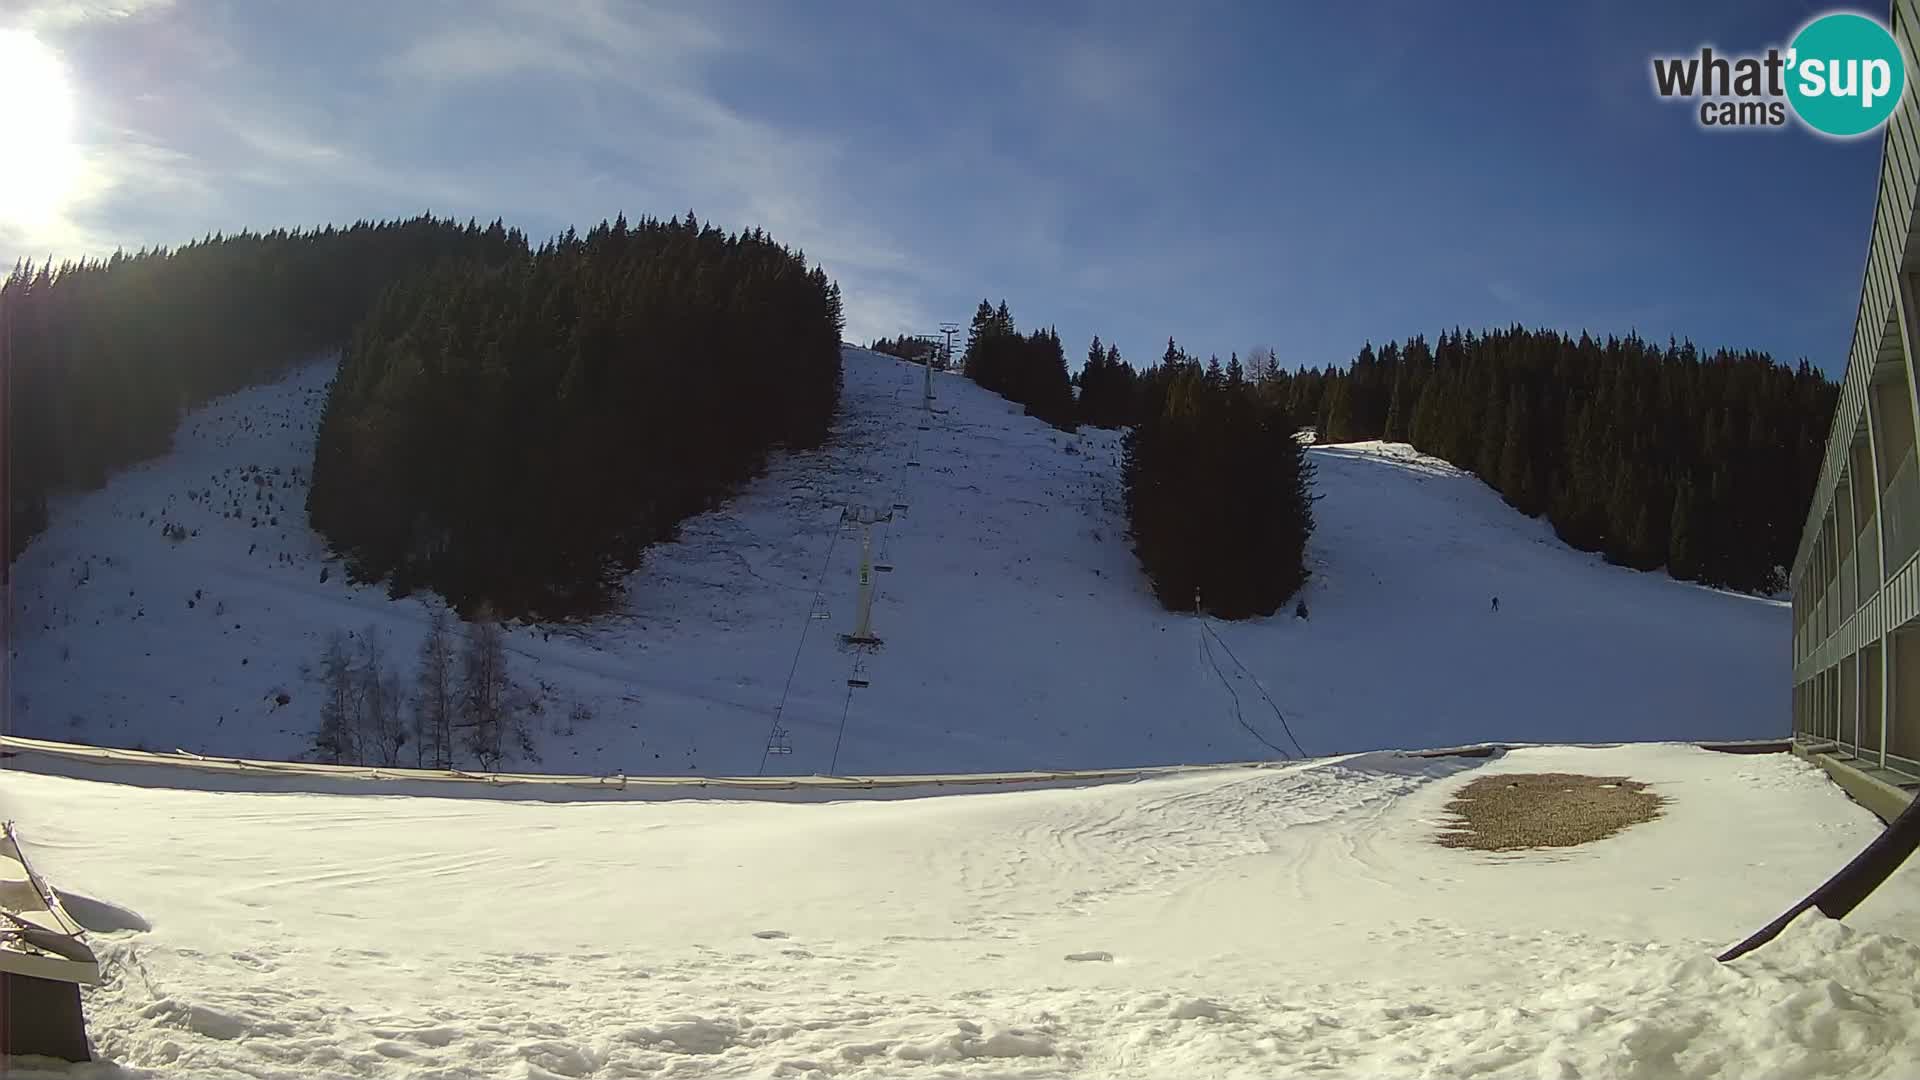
0, 217, 526, 565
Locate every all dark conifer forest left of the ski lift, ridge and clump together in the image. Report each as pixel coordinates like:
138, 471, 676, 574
0, 211, 843, 617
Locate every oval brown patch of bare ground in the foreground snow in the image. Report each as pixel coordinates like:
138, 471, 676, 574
1434, 773, 1667, 851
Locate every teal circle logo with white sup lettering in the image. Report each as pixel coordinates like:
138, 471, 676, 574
1788, 12, 1907, 138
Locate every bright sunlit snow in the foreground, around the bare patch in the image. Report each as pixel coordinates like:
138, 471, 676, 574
0, 744, 1920, 1080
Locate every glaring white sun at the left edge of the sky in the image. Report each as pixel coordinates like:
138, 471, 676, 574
0, 31, 81, 225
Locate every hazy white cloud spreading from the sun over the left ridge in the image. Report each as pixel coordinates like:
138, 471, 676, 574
0, 0, 947, 336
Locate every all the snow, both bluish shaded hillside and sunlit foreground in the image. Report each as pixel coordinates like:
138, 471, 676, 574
0, 348, 1850, 1080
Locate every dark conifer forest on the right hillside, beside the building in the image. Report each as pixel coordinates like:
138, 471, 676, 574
1271, 327, 1839, 592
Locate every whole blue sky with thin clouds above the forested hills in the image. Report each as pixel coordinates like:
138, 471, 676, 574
0, 0, 1885, 373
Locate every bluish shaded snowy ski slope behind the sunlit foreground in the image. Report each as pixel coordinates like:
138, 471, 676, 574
10, 350, 1788, 774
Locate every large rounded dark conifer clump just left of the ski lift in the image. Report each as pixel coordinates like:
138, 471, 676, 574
307, 211, 845, 619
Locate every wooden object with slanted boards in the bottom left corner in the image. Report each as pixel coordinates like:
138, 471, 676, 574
0, 822, 100, 1061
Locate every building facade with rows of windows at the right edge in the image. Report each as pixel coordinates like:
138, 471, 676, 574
1791, 0, 1920, 792
